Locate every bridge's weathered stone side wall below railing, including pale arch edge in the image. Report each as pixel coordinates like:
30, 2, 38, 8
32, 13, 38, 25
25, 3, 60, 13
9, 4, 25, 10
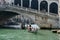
14, 14, 59, 28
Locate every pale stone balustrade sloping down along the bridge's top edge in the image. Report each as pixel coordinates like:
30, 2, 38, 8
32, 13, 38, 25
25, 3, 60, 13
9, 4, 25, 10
0, 5, 58, 18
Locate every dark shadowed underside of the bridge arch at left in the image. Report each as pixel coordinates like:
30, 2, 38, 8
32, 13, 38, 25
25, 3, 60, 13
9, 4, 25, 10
0, 11, 19, 25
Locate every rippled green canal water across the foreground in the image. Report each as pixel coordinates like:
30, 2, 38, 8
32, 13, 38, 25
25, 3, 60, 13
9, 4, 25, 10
0, 29, 59, 40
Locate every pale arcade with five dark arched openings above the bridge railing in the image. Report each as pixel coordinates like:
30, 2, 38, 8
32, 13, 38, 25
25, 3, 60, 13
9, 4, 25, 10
14, 0, 58, 14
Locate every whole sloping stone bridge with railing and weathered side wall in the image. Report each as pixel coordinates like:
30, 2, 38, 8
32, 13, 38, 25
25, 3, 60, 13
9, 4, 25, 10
0, 5, 59, 27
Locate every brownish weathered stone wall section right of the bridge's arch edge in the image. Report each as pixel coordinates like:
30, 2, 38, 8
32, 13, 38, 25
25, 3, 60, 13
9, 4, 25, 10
36, 14, 58, 28
